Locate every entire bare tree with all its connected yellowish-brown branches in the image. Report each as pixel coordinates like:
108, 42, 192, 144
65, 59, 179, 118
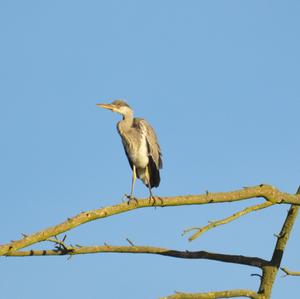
0, 184, 300, 299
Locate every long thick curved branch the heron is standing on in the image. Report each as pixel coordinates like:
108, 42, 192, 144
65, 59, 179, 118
0, 184, 300, 256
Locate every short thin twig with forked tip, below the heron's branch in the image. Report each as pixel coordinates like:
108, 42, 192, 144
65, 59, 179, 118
183, 201, 274, 241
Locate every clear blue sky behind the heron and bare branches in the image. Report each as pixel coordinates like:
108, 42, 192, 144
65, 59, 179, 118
0, 0, 300, 299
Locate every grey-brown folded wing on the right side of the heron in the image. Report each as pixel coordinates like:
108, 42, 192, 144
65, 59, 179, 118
134, 118, 163, 169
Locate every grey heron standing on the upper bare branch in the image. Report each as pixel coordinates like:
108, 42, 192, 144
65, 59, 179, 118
96, 99, 163, 203
